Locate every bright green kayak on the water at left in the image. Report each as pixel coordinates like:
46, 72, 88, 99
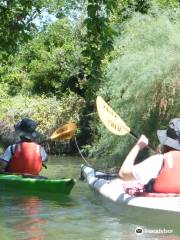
0, 174, 76, 195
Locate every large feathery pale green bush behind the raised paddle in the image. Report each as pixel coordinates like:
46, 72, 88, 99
92, 9, 180, 165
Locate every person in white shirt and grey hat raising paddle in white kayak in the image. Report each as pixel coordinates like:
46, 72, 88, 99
119, 118, 180, 194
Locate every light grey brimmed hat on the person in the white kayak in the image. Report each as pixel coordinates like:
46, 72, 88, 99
157, 118, 180, 150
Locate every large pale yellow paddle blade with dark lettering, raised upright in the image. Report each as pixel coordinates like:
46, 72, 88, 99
96, 96, 130, 135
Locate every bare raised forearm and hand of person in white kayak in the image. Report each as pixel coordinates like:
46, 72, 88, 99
119, 135, 148, 180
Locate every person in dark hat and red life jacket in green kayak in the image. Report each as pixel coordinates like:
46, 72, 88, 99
0, 118, 48, 176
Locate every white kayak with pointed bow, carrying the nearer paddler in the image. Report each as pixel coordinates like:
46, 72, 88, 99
81, 165, 180, 215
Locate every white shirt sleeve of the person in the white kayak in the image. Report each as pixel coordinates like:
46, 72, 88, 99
132, 154, 163, 184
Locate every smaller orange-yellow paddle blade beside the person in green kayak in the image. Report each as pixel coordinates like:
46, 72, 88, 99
50, 123, 77, 141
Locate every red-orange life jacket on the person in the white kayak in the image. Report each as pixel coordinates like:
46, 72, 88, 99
153, 151, 180, 193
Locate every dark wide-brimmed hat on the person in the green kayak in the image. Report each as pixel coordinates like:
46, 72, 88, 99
14, 118, 40, 140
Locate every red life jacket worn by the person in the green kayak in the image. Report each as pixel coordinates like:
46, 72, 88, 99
6, 142, 42, 175
